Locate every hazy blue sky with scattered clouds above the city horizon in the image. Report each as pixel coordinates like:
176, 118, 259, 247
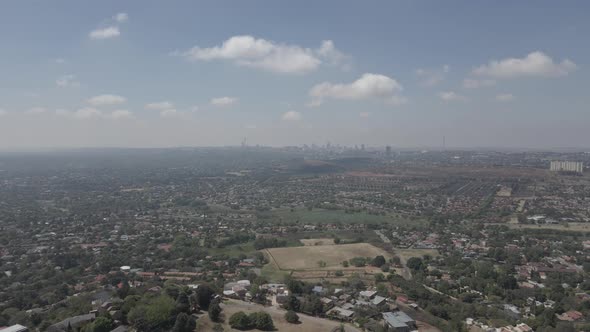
0, 0, 590, 149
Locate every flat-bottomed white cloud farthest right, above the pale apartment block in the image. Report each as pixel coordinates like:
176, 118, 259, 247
473, 51, 576, 78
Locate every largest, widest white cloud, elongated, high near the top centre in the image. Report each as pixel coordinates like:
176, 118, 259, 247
174, 35, 347, 74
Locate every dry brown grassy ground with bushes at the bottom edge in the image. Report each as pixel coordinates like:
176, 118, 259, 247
197, 300, 360, 332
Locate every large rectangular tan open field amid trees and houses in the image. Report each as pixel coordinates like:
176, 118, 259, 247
266, 243, 391, 270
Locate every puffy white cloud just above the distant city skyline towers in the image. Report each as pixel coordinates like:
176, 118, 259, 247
308, 73, 406, 106
